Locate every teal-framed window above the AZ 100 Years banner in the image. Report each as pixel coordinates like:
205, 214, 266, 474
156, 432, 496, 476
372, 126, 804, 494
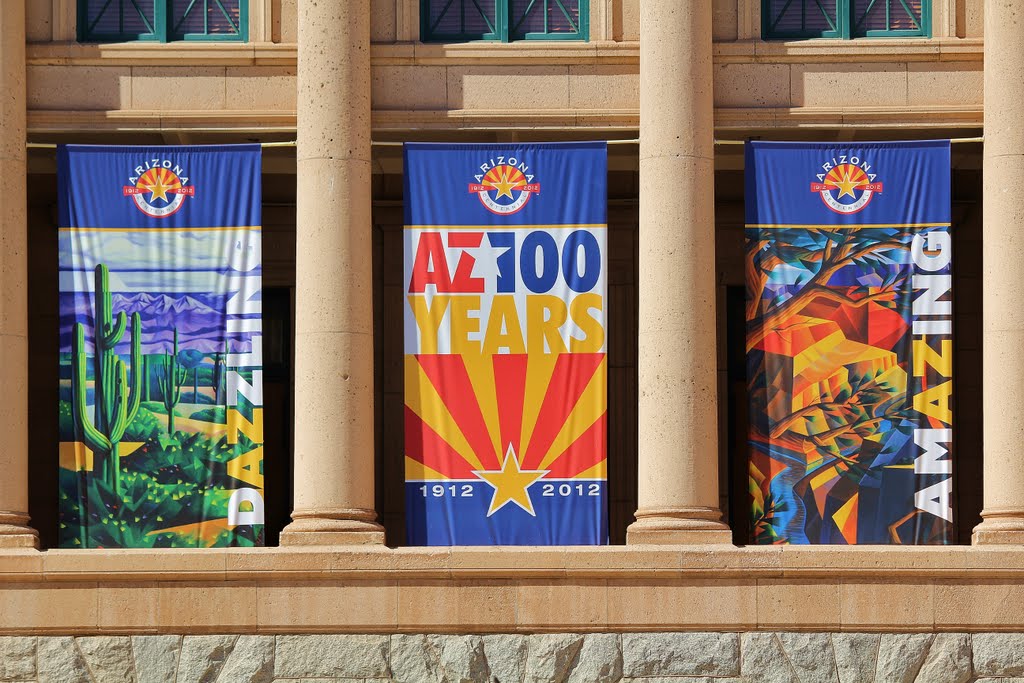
420, 0, 590, 42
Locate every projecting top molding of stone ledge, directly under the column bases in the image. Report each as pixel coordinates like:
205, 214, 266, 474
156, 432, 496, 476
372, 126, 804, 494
6, 546, 1024, 583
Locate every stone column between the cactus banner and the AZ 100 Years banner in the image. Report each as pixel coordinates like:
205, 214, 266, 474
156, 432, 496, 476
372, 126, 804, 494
281, 0, 384, 545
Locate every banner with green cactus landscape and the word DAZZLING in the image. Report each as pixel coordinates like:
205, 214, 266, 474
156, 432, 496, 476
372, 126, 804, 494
57, 145, 264, 548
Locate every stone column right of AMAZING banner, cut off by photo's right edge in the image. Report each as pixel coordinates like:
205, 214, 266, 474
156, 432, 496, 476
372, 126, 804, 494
969, 0, 1024, 545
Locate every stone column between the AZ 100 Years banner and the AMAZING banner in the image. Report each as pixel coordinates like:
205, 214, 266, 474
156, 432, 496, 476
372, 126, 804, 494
627, 0, 732, 544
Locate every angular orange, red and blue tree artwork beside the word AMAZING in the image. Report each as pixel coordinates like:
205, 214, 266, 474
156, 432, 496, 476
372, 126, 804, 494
745, 227, 912, 543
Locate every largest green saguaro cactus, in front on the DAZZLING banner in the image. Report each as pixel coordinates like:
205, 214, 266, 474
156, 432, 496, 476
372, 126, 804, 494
72, 264, 142, 495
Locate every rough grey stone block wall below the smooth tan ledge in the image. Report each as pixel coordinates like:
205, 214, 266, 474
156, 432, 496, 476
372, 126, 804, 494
0, 633, 1024, 683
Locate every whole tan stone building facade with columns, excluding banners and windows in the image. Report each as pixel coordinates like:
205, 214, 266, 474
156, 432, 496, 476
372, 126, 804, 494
6, 0, 1024, 683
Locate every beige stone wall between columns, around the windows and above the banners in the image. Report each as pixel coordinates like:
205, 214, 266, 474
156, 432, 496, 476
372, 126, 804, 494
19, 0, 982, 133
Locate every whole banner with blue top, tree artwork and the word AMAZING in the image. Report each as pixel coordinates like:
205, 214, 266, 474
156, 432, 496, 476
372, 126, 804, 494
745, 141, 953, 545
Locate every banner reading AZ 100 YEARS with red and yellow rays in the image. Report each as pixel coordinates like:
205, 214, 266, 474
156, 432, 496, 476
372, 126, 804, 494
403, 142, 608, 546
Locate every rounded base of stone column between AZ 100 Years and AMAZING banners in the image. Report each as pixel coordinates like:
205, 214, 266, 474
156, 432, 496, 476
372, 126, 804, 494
626, 507, 732, 546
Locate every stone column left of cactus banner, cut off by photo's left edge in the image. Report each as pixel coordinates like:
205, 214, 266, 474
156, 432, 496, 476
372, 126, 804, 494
0, 0, 39, 548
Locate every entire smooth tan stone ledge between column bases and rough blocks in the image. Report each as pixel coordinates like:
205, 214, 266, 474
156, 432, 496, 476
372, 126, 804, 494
0, 546, 1024, 634
